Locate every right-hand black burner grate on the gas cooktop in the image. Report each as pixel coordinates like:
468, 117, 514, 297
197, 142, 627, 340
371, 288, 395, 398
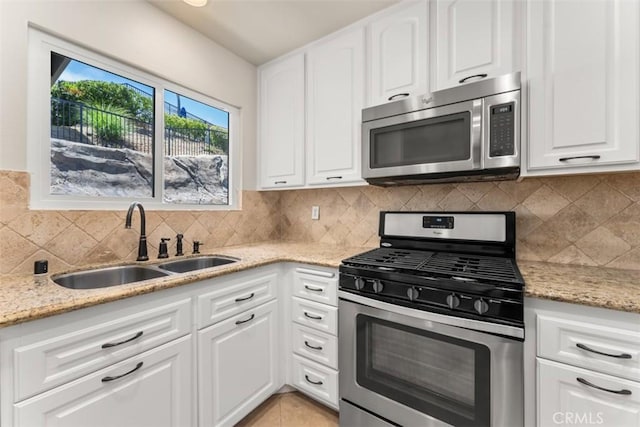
418, 252, 523, 284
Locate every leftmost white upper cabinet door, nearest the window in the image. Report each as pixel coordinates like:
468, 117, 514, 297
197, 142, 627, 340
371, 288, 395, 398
258, 54, 304, 188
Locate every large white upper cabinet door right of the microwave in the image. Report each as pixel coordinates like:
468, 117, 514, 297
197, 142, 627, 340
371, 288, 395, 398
527, 0, 640, 171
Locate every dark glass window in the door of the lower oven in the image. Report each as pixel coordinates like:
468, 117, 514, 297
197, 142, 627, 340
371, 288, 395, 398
356, 314, 491, 426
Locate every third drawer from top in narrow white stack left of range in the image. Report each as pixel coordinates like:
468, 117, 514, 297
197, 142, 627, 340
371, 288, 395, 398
291, 323, 338, 369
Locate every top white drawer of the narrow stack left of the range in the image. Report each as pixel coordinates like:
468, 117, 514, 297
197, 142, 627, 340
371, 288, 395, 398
293, 268, 338, 307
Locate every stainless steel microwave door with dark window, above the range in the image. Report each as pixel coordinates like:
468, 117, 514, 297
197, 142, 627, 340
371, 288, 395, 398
362, 99, 482, 179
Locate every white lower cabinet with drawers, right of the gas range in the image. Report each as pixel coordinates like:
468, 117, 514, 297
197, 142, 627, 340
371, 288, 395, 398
524, 298, 640, 427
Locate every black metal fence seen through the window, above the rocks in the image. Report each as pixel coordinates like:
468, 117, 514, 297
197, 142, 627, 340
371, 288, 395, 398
51, 97, 229, 156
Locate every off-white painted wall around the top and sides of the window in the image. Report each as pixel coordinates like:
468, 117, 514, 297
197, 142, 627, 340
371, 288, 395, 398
0, 0, 257, 188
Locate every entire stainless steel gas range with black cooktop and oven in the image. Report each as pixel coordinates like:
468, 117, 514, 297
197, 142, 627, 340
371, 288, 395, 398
338, 212, 524, 427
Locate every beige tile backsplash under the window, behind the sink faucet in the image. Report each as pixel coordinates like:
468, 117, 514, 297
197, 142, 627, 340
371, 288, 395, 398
0, 171, 280, 274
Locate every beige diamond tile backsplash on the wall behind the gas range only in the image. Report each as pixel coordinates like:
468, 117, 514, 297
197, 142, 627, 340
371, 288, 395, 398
280, 173, 640, 270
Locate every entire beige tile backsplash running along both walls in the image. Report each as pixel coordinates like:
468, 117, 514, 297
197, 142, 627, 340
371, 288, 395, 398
0, 171, 640, 274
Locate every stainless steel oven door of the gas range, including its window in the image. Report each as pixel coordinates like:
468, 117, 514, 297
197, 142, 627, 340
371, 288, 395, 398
338, 291, 524, 427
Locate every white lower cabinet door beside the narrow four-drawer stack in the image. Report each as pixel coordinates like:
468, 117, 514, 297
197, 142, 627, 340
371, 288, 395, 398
198, 301, 280, 426
